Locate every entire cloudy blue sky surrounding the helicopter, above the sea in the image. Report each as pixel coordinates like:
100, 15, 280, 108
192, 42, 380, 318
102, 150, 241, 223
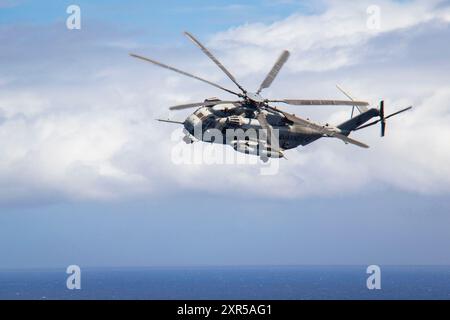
0, 0, 450, 269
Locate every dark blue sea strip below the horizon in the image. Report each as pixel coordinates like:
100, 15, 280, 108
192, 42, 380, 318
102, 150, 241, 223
0, 266, 450, 300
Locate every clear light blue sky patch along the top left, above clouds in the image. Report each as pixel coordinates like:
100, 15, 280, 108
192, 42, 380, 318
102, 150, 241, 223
2, 0, 322, 38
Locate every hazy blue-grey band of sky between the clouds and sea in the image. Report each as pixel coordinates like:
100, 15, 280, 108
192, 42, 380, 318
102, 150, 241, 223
0, 193, 450, 268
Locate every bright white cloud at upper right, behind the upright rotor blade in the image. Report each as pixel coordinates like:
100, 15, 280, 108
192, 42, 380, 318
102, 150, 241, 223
210, 0, 450, 75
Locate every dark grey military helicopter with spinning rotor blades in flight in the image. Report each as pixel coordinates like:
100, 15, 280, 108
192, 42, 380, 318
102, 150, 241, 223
130, 32, 412, 162
